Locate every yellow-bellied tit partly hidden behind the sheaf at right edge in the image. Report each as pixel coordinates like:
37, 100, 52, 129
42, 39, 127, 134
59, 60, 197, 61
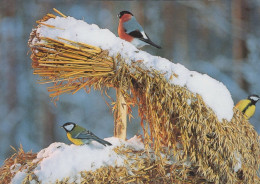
236, 94, 260, 119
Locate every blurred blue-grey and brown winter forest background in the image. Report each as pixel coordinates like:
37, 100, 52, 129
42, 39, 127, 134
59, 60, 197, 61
0, 0, 260, 164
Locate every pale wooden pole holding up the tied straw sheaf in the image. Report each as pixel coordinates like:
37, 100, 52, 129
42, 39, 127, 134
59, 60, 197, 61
114, 88, 127, 140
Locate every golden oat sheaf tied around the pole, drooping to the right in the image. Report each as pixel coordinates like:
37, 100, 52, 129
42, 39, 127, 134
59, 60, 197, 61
24, 11, 260, 183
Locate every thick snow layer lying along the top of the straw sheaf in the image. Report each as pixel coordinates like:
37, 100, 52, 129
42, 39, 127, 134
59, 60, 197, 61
32, 17, 234, 121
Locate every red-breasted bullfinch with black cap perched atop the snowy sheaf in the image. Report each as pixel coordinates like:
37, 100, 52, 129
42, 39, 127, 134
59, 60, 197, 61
117, 11, 161, 49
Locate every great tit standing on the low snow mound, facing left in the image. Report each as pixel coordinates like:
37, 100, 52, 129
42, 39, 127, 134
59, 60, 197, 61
61, 122, 112, 146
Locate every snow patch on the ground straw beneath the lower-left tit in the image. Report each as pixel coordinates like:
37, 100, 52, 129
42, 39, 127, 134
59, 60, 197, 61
12, 136, 144, 184
